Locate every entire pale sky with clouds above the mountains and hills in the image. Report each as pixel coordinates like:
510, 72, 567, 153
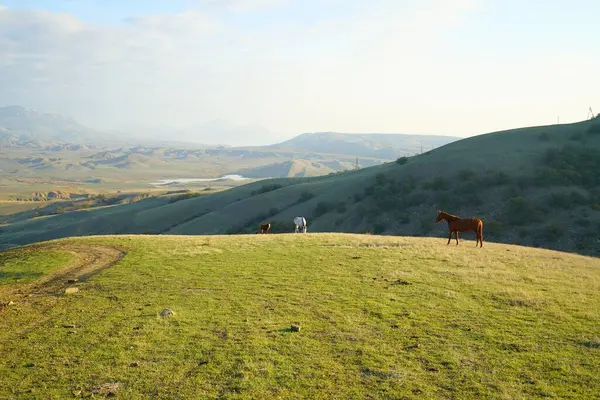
0, 0, 600, 144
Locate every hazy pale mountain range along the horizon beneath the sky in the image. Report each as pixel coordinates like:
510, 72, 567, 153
0, 106, 460, 154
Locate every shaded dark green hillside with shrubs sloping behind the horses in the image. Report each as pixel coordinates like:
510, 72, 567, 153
0, 119, 600, 254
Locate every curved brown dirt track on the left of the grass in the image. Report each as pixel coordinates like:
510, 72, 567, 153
0, 243, 127, 312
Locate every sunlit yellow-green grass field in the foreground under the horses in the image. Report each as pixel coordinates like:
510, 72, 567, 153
0, 233, 600, 399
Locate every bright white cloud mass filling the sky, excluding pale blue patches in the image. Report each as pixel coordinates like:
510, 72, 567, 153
0, 0, 598, 141
